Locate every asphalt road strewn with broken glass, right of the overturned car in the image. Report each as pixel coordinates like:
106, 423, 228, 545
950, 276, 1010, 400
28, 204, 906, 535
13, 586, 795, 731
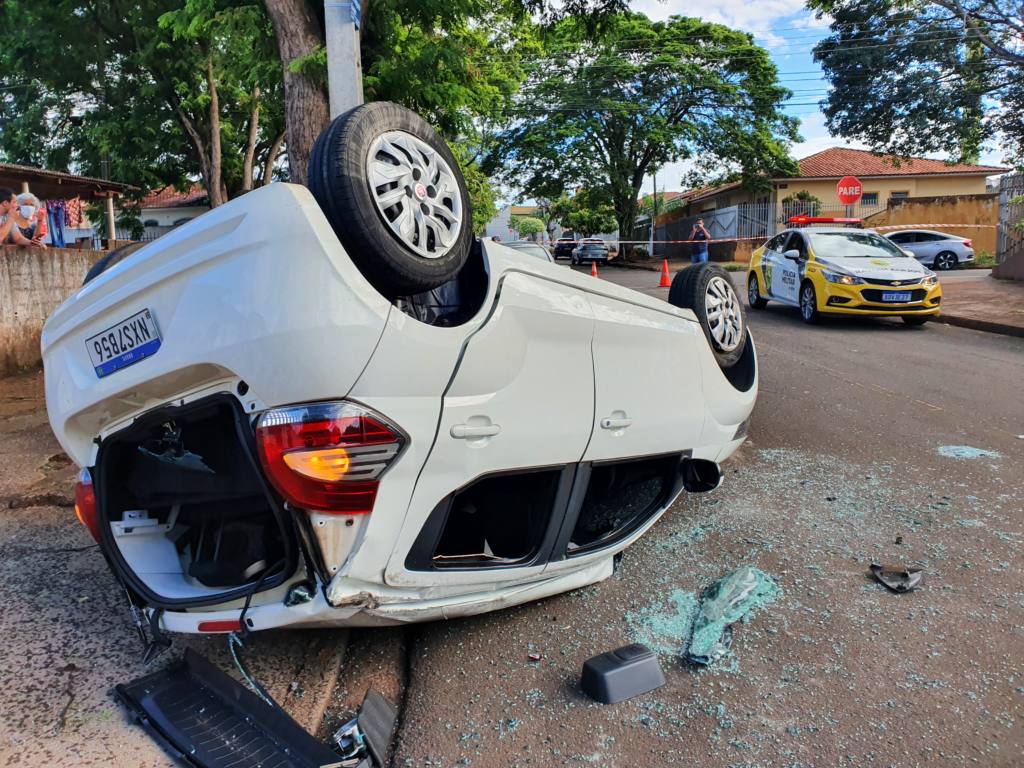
395, 268, 1024, 768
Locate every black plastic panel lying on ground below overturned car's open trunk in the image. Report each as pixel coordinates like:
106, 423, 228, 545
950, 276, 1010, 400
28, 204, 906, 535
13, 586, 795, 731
114, 650, 345, 768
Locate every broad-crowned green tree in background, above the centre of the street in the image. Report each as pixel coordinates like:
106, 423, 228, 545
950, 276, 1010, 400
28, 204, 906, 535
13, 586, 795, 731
490, 13, 797, 237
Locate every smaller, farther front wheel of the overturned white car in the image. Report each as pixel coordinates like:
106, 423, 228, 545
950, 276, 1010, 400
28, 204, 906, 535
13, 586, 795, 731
669, 264, 748, 371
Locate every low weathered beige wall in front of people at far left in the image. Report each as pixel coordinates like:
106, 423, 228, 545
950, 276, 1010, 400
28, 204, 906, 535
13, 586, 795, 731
0, 246, 103, 376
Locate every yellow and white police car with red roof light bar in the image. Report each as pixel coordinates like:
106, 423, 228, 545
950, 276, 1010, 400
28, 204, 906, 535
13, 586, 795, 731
746, 219, 942, 326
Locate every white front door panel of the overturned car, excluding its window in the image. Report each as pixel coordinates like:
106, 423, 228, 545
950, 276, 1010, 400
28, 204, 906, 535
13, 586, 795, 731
584, 294, 706, 462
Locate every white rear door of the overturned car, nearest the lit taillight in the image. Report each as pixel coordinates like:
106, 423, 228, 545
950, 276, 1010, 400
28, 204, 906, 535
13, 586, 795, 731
385, 271, 594, 587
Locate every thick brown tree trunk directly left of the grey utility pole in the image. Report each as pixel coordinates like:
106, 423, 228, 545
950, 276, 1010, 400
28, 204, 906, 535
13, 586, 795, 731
266, 0, 331, 184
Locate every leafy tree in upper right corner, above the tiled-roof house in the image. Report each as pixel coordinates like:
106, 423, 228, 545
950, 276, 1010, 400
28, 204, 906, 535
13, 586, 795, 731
808, 0, 1024, 163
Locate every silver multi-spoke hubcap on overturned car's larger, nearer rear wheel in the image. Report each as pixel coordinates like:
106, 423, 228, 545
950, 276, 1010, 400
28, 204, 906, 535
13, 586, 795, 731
366, 131, 463, 259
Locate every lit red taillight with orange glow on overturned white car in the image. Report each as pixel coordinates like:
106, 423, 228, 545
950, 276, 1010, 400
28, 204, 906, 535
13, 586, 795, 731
256, 402, 402, 515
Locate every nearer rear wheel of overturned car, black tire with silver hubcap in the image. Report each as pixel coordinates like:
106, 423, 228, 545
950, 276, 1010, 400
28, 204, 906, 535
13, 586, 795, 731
308, 101, 473, 299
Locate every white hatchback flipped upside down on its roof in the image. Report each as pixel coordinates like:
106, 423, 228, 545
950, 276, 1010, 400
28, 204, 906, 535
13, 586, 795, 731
43, 102, 758, 643
